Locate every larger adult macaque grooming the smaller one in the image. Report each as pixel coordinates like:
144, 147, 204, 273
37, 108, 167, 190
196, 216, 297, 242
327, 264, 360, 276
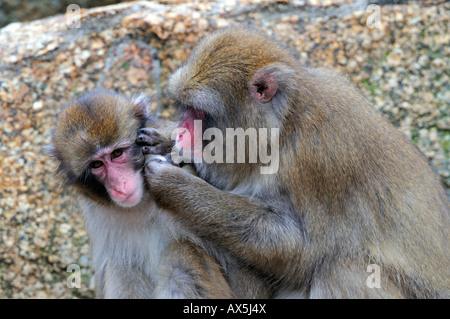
145, 27, 450, 298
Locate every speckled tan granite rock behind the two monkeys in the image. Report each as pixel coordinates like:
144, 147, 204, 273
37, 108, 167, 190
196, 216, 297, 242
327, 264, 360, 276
0, 0, 450, 298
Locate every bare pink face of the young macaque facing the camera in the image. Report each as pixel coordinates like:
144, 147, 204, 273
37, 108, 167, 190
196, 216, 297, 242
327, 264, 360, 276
91, 148, 144, 207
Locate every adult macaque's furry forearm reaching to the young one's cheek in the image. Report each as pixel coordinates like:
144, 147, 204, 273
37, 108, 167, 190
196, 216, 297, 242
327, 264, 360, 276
146, 161, 304, 276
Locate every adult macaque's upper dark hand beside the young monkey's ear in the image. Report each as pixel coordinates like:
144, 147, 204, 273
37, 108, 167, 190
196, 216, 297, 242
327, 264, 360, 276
136, 127, 174, 155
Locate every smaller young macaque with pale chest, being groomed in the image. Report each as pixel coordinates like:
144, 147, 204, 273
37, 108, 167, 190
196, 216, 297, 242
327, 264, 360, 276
50, 91, 233, 298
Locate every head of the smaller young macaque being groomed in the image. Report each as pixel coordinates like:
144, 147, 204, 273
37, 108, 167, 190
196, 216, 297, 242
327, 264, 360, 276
50, 90, 149, 207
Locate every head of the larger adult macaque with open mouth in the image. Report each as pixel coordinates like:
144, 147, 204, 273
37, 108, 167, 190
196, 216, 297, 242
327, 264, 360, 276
167, 28, 297, 159
